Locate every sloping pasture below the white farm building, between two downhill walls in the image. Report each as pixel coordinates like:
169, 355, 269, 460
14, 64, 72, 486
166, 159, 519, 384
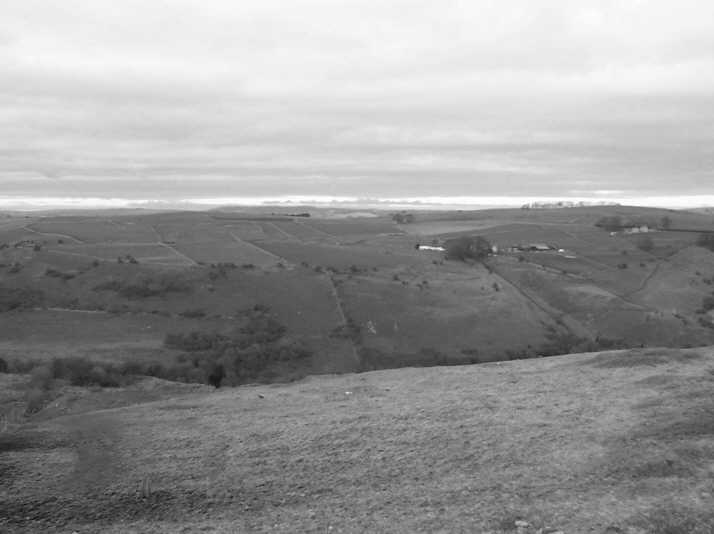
338, 267, 553, 367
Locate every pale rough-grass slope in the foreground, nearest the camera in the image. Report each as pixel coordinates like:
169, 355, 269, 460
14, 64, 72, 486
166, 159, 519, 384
0, 349, 714, 534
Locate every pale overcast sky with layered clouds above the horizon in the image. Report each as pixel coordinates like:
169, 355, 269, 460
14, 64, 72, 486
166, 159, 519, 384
0, 0, 714, 206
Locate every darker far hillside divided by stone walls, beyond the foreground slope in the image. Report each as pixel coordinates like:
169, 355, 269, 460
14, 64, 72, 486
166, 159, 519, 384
0, 206, 714, 386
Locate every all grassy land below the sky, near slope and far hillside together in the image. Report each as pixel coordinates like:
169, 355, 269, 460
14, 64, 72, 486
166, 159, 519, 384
0, 206, 714, 534
